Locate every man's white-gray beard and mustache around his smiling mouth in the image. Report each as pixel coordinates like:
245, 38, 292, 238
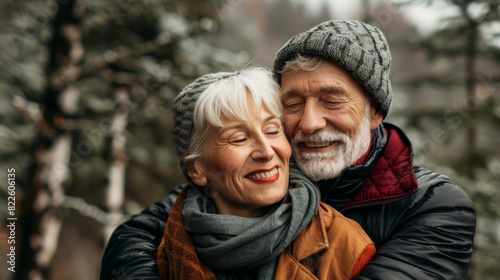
292, 106, 371, 182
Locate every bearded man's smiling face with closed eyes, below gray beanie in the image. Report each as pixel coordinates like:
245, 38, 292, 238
281, 61, 383, 181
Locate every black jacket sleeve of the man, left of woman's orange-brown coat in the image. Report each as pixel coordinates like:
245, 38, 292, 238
100, 186, 183, 280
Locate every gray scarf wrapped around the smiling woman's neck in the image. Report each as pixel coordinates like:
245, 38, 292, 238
182, 161, 320, 279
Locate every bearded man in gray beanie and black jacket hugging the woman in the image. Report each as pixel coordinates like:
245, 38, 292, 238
101, 21, 476, 279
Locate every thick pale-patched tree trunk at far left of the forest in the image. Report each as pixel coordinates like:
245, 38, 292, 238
16, 0, 84, 279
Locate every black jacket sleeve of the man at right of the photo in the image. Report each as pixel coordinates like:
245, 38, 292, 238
354, 169, 476, 280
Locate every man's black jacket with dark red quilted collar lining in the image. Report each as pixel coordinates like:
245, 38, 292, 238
101, 124, 476, 279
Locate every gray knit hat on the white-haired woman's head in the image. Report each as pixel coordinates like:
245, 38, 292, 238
173, 72, 237, 183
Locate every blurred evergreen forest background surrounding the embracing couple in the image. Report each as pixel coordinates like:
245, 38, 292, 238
0, 0, 500, 280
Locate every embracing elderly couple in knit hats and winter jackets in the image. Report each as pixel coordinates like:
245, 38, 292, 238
101, 21, 476, 279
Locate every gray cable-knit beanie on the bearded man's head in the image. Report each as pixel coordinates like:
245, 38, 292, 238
273, 20, 392, 119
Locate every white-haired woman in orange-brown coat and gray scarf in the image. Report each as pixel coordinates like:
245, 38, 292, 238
156, 68, 375, 279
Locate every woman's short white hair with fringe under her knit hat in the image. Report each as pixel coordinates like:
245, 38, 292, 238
184, 67, 282, 162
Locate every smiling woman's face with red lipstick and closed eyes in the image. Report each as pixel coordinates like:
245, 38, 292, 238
189, 93, 291, 217
